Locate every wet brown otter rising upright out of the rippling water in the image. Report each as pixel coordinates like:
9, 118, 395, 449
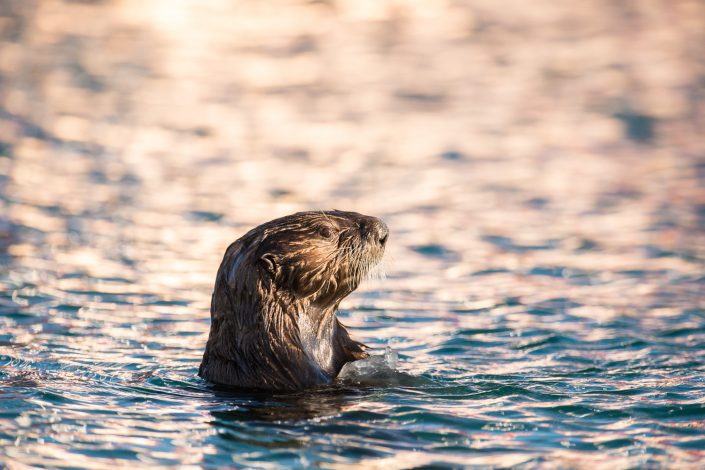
198, 210, 389, 391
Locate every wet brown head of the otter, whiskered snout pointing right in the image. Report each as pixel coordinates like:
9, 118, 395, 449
250, 210, 389, 307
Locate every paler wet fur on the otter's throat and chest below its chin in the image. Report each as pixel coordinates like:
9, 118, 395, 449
297, 305, 337, 378
